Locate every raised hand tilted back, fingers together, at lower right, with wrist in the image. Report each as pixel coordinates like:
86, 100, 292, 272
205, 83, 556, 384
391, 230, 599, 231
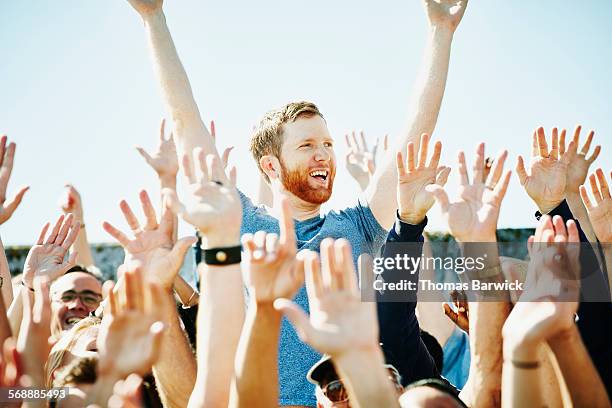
503, 215, 580, 349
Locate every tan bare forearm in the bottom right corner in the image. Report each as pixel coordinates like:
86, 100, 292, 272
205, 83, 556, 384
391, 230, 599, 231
548, 326, 610, 407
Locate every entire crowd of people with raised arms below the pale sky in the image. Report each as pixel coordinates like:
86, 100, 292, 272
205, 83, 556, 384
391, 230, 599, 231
0, 0, 612, 408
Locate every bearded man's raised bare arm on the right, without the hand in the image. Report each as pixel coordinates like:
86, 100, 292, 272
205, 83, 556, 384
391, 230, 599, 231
366, 26, 453, 228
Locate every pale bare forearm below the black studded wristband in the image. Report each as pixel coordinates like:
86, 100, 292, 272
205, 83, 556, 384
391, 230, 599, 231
189, 264, 244, 407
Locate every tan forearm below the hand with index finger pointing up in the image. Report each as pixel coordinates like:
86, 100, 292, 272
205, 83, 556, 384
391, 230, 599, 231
230, 302, 281, 407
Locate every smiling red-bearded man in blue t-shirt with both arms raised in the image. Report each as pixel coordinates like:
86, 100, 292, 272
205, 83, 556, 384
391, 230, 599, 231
123, 0, 468, 407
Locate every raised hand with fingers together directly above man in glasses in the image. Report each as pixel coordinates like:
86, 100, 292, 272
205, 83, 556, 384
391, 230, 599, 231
23, 214, 81, 289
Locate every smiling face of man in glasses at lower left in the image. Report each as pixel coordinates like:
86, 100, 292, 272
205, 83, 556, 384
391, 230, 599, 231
49, 266, 102, 338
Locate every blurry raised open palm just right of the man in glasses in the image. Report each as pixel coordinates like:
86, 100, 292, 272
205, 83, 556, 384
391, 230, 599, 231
97, 264, 165, 379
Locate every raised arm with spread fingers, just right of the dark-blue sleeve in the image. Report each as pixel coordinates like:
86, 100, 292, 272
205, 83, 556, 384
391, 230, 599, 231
427, 143, 511, 407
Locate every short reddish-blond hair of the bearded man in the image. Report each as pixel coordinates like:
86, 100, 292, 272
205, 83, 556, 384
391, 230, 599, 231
250, 101, 323, 182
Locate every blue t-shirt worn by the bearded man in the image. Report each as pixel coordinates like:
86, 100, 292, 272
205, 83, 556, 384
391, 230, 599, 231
240, 192, 387, 406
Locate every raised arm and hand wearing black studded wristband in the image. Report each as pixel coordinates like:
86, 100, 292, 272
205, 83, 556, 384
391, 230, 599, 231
164, 149, 244, 407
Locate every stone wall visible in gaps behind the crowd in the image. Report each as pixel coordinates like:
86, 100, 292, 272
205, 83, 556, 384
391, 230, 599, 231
5, 229, 533, 282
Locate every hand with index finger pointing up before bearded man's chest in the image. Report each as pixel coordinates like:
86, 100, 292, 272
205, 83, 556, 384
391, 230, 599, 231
242, 198, 304, 303
